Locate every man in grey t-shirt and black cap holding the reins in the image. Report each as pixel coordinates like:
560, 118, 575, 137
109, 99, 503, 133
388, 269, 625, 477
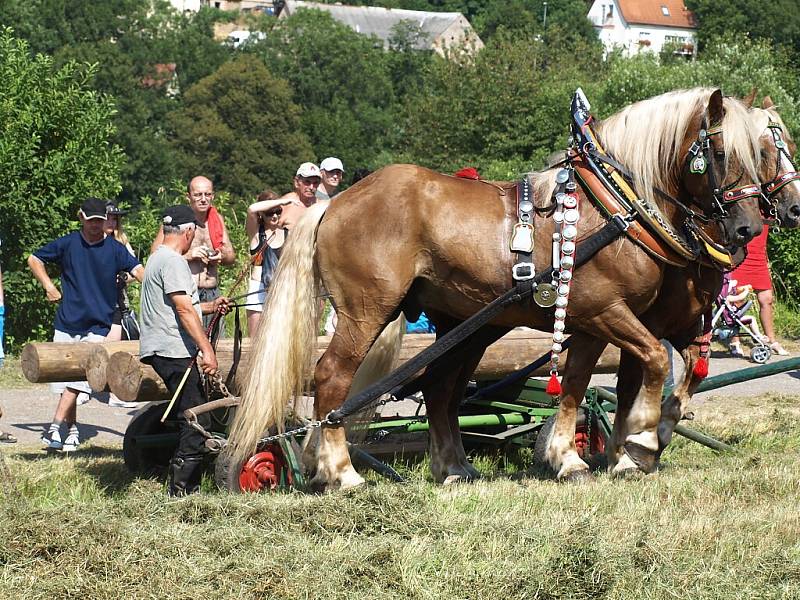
139, 205, 229, 496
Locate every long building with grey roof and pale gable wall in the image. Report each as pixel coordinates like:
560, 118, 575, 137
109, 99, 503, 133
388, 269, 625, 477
278, 0, 483, 55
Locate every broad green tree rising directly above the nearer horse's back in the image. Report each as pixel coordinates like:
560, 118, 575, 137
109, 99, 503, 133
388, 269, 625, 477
402, 33, 599, 178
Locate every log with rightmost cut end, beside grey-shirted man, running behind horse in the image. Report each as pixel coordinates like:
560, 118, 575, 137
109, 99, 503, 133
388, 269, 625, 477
108, 330, 619, 402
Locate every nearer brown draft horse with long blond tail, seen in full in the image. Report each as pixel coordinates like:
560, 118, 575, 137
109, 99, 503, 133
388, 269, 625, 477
230, 88, 761, 489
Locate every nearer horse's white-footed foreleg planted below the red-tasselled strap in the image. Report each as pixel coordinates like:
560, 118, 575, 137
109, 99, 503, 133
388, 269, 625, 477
547, 332, 606, 481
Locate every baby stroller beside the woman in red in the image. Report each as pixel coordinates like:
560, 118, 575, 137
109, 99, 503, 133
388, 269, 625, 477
711, 275, 772, 365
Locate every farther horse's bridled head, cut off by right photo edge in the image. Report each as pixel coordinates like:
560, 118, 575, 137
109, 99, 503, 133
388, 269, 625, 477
752, 96, 800, 227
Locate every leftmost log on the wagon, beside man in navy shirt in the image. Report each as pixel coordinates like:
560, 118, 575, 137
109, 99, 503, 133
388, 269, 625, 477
20, 338, 250, 389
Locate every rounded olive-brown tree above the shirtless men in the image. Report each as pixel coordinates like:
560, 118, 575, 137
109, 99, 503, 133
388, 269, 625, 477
169, 55, 314, 198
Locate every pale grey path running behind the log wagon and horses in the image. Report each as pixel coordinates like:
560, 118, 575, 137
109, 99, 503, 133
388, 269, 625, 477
0, 357, 800, 446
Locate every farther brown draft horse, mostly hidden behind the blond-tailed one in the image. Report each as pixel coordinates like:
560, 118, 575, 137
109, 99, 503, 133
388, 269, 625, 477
607, 99, 800, 460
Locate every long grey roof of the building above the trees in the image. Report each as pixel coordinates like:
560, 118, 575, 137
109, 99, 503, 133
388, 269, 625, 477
282, 0, 470, 50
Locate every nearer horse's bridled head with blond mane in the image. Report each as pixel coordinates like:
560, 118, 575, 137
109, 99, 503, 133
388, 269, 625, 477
598, 88, 762, 252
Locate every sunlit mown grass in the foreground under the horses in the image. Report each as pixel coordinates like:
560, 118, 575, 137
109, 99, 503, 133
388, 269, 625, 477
0, 396, 800, 600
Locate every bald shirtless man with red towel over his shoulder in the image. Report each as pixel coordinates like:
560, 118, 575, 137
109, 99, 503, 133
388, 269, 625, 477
150, 175, 236, 328
